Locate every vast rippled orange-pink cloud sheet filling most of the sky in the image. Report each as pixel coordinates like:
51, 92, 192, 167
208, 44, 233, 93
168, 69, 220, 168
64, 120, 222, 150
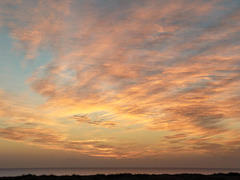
1, 1, 240, 157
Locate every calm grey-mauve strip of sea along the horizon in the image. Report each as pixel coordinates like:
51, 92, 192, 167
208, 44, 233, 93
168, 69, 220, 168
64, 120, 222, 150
0, 168, 240, 177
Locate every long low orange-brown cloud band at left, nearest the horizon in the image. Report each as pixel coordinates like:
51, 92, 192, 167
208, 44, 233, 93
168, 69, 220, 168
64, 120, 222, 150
0, 127, 119, 157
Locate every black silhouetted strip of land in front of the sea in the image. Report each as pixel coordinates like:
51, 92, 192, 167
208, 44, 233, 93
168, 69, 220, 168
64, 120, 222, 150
0, 173, 240, 180
